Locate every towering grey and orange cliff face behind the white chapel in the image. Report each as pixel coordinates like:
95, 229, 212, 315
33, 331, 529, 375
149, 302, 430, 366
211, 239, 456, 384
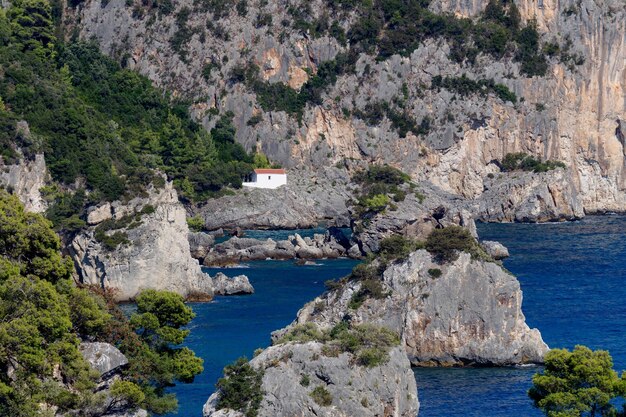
66, 0, 626, 216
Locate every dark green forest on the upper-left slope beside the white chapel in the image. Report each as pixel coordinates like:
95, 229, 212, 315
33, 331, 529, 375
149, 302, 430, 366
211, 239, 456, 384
0, 0, 253, 221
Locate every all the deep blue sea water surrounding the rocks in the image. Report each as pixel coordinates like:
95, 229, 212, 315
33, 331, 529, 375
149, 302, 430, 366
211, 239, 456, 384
168, 216, 626, 417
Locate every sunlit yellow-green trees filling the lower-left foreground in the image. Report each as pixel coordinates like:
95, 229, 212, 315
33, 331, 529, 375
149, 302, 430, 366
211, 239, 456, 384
0, 191, 202, 417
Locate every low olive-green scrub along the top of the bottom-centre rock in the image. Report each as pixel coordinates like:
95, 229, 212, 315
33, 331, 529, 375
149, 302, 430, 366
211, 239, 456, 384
274, 321, 400, 367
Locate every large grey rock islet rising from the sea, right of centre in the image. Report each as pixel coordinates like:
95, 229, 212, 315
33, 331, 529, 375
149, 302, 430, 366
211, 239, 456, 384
282, 250, 548, 366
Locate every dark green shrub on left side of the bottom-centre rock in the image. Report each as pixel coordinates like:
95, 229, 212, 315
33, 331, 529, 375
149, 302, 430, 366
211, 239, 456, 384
216, 358, 264, 417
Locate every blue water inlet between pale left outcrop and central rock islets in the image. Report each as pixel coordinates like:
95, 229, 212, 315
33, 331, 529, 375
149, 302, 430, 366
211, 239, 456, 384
171, 259, 356, 417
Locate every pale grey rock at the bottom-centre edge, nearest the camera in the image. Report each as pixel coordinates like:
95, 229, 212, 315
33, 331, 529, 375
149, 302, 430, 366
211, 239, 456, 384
203, 342, 419, 417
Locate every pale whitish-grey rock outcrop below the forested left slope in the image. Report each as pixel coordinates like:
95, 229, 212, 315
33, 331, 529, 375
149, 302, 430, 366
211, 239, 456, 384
69, 183, 213, 301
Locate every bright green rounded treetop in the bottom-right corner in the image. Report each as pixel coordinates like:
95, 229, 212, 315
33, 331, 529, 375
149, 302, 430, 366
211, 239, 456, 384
528, 346, 626, 417
